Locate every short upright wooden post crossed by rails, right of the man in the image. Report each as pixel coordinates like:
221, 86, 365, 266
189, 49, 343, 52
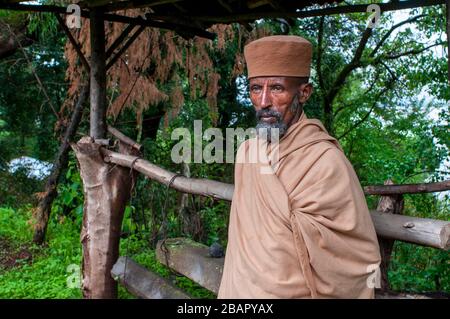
377, 179, 403, 292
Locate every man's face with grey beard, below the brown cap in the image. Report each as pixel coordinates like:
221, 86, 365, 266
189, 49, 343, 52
249, 77, 311, 139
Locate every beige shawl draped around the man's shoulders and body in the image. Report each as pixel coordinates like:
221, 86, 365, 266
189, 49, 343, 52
218, 113, 380, 298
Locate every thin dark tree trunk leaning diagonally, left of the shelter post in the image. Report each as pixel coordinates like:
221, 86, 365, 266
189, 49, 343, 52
33, 84, 89, 245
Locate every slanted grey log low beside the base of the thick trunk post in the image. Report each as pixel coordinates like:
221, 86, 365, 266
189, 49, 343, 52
111, 257, 190, 299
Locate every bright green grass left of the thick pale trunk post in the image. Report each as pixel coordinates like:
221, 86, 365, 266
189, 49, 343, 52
0, 208, 81, 298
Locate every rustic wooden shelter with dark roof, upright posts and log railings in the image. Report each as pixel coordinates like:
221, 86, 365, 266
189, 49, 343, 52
0, 0, 450, 298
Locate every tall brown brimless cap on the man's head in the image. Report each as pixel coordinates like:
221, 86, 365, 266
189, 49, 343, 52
244, 35, 312, 78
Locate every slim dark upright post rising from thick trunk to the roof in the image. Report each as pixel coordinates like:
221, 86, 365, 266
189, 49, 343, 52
90, 9, 107, 139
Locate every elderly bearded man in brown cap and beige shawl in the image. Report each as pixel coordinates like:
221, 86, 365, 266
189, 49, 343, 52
218, 36, 380, 298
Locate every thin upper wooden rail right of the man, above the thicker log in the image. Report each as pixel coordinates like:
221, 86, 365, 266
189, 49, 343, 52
364, 180, 450, 195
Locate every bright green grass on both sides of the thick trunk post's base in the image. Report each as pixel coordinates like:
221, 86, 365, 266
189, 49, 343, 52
0, 208, 215, 299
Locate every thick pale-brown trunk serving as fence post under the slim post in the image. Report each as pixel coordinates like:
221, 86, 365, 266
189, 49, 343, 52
72, 137, 138, 299
